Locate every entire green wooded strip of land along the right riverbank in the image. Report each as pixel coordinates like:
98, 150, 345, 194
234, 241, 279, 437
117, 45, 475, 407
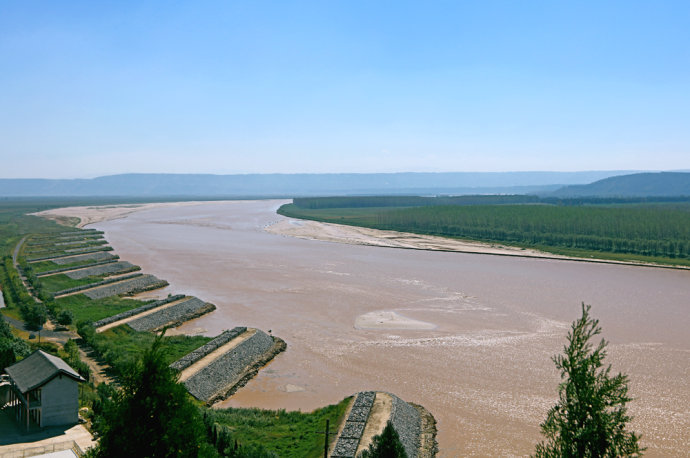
278, 196, 690, 265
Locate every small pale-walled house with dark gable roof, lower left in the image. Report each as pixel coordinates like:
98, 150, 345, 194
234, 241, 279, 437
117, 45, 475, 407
5, 350, 85, 430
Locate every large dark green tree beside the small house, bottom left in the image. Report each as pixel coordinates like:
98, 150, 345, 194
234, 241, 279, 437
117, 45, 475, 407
90, 335, 205, 457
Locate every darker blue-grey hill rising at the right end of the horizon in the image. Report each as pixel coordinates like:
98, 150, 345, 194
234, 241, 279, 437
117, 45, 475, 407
550, 172, 690, 197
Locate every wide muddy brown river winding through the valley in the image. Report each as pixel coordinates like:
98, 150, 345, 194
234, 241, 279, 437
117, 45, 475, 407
89, 201, 690, 457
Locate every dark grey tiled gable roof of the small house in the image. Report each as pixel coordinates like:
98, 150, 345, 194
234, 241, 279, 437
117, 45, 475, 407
5, 350, 84, 393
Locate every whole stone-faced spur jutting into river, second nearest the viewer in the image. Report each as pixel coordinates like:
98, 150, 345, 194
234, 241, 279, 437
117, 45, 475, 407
184, 330, 286, 404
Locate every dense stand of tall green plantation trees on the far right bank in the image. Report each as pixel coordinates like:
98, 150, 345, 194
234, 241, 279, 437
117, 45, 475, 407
375, 205, 690, 258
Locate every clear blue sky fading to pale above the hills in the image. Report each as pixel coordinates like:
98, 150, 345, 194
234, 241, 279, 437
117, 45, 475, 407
0, 0, 690, 178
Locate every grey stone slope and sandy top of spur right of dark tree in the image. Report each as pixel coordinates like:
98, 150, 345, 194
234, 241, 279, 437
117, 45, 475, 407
184, 330, 274, 402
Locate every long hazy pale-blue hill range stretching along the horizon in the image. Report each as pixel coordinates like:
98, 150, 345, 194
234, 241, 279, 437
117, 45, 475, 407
0, 171, 630, 197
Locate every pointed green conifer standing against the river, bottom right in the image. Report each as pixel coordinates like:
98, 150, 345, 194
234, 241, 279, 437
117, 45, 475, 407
536, 303, 644, 457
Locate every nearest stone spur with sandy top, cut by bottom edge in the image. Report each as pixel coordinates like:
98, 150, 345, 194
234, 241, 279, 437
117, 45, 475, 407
330, 391, 437, 458
